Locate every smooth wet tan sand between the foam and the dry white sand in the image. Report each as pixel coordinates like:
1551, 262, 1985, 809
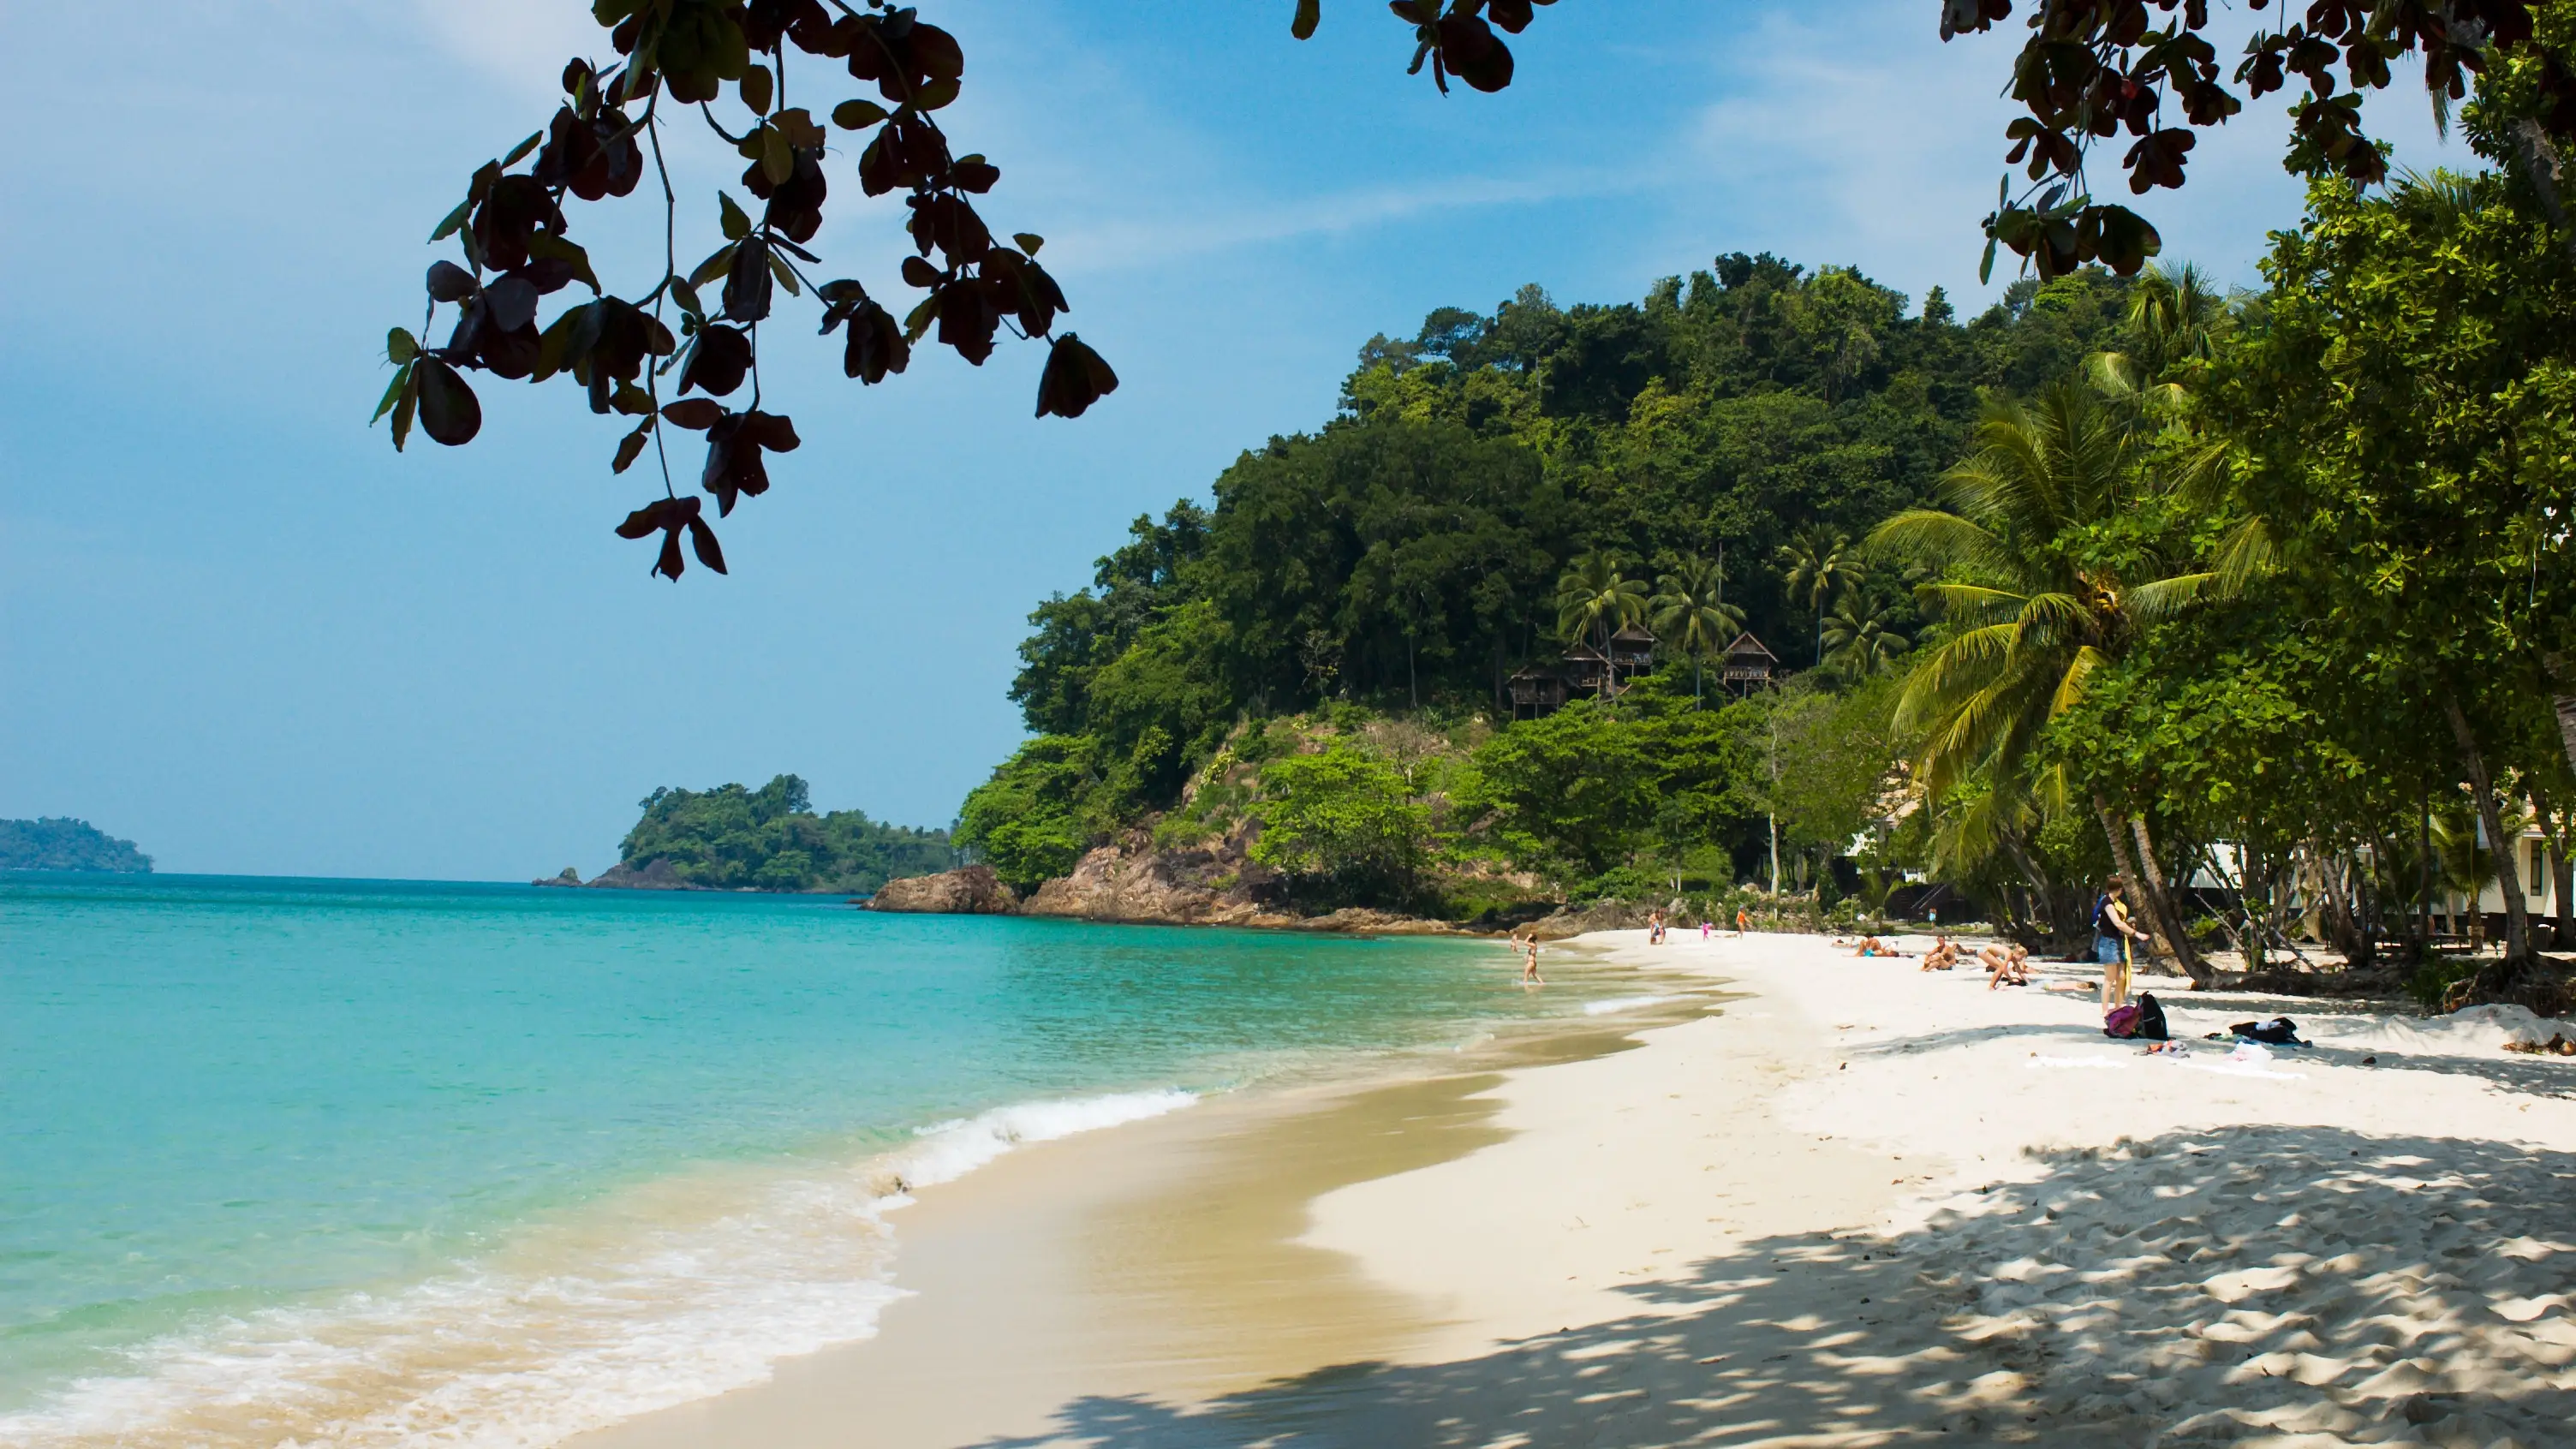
572, 969, 1708, 1449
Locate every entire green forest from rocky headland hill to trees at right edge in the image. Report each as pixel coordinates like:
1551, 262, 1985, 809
958, 158, 2576, 995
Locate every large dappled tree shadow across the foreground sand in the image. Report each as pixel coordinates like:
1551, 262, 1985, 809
987, 1127, 2576, 1449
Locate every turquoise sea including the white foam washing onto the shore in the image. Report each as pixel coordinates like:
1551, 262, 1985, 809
0, 874, 1600, 1446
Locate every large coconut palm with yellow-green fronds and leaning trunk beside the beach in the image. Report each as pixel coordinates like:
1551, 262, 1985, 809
1870, 382, 2218, 977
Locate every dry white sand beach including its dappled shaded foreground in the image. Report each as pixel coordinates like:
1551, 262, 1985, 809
595, 933, 2576, 1449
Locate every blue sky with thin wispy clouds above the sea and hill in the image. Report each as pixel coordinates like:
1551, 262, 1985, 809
0, 0, 2460, 880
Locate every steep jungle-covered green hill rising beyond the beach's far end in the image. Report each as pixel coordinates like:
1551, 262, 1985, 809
961, 255, 2128, 903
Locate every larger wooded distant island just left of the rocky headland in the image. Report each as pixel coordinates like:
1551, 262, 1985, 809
553, 776, 956, 895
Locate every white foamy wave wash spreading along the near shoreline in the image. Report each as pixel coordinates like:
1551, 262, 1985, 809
0, 1091, 1198, 1449
